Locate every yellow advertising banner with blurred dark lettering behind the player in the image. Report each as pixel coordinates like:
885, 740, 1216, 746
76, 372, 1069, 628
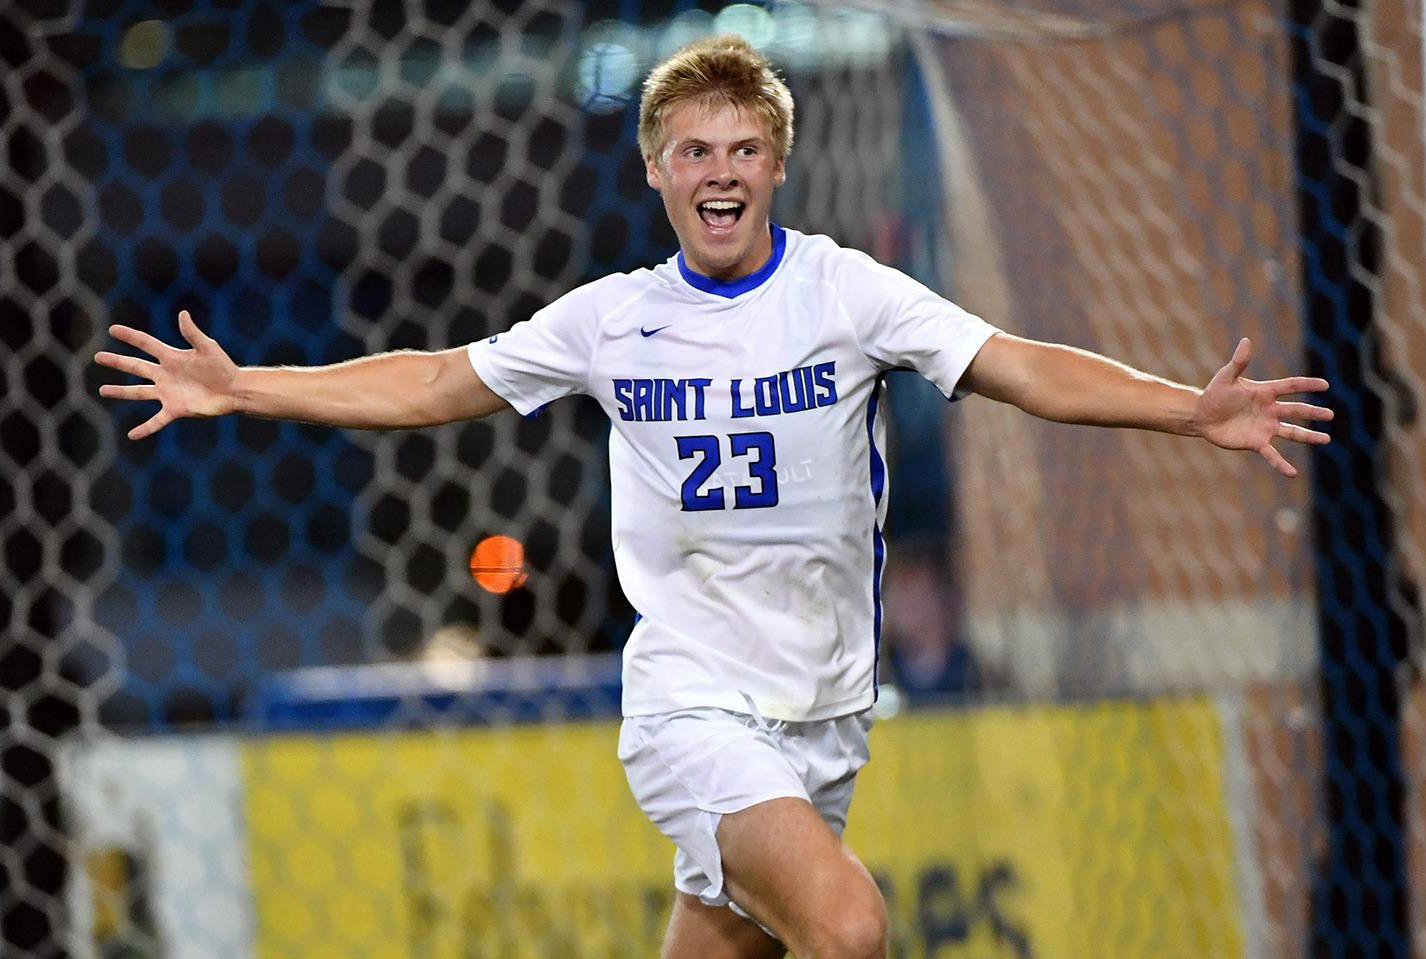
242, 701, 1242, 959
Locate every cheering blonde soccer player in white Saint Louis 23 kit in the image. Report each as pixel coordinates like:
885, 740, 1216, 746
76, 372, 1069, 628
97, 37, 1332, 959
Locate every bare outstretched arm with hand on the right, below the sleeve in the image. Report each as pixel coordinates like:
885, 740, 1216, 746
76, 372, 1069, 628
961, 333, 1332, 476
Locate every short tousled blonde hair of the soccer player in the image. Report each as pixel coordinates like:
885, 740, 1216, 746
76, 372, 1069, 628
639, 33, 793, 158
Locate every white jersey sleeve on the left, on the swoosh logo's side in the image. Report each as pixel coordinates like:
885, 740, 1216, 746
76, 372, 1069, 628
466, 291, 597, 416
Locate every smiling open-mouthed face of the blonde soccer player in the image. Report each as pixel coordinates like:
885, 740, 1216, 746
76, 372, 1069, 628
645, 100, 787, 279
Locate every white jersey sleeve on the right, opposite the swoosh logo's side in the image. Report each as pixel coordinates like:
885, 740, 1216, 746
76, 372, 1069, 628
838, 254, 1000, 399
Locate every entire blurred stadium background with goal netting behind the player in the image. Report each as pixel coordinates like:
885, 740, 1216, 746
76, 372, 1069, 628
0, 0, 1426, 956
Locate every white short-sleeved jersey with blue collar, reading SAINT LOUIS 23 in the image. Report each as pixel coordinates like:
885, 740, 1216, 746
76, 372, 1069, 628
469, 227, 995, 721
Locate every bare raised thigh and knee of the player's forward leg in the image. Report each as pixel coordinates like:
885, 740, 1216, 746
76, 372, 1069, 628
717, 799, 887, 959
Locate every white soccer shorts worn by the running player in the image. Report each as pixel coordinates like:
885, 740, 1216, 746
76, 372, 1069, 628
619, 701, 871, 916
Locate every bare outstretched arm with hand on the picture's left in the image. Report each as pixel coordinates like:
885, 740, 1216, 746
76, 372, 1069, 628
94, 311, 508, 439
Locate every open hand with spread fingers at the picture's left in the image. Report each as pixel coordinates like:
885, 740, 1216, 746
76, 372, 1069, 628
94, 309, 238, 439
